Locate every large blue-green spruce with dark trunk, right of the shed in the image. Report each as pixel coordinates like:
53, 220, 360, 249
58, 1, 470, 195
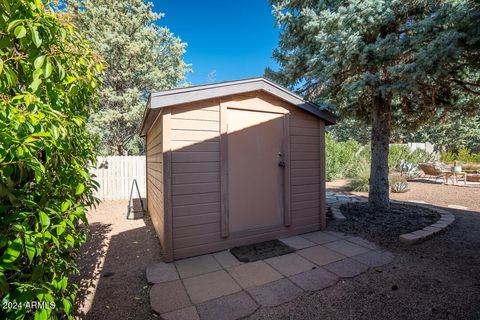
267, 0, 480, 209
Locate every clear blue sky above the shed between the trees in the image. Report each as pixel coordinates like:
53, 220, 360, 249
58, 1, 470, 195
153, 0, 279, 85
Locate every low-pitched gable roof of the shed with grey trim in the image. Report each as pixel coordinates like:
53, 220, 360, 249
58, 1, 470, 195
140, 77, 335, 137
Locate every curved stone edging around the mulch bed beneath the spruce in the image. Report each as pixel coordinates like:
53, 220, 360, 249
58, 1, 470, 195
329, 200, 455, 245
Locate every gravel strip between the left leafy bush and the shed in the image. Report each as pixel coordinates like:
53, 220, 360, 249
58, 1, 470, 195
74, 201, 161, 320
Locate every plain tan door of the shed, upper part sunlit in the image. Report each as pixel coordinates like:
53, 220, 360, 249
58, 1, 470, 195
227, 109, 284, 232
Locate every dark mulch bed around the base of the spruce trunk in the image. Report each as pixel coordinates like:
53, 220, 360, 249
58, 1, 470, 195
334, 203, 440, 247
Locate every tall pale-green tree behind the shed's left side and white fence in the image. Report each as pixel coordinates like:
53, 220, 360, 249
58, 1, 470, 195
65, 0, 188, 155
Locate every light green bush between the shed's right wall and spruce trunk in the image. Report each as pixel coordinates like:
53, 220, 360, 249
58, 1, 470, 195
325, 133, 360, 181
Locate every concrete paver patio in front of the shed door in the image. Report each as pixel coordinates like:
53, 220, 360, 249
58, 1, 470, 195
147, 231, 394, 320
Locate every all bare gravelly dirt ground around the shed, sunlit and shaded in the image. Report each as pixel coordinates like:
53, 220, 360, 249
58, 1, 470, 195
75, 181, 480, 320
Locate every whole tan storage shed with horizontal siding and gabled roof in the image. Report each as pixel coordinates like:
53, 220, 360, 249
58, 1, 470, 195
141, 78, 335, 261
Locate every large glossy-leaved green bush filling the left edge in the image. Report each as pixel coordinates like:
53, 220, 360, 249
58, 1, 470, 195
0, 0, 102, 319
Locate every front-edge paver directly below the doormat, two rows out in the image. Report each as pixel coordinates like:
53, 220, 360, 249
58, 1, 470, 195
247, 279, 303, 307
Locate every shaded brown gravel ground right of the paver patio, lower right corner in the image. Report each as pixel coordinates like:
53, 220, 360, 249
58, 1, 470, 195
249, 211, 480, 320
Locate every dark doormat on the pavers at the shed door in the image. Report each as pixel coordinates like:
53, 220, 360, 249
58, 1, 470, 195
230, 240, 295, 262
